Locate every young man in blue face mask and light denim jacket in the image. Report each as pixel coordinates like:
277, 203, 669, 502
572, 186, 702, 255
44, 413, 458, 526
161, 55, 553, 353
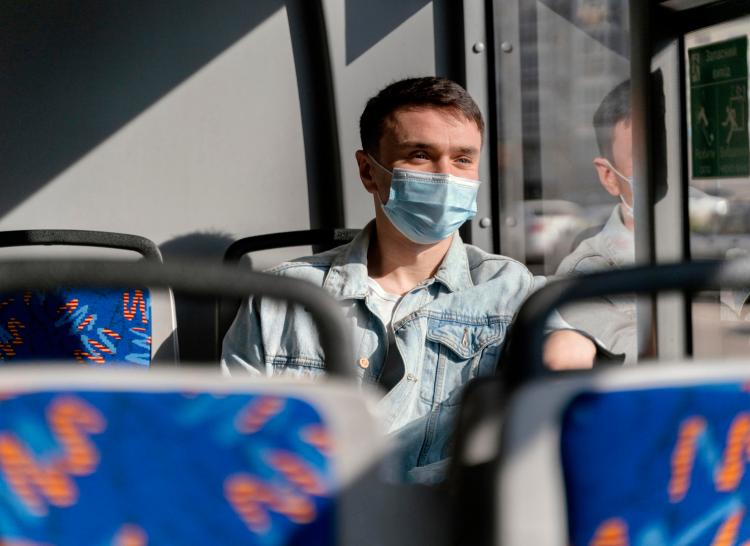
222, 77, 595, 482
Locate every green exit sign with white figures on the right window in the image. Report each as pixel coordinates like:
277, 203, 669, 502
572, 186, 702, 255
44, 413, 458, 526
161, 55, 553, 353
688, 36, 750, 178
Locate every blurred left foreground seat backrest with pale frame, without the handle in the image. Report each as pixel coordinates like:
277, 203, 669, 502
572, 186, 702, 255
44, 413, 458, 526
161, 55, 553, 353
0, 366, 387, 546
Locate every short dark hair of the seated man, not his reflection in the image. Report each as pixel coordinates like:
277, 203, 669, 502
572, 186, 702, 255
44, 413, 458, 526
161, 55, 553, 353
359, 76, 484, 153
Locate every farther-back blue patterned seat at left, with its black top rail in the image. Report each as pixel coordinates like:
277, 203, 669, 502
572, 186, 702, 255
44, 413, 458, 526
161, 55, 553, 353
0, 230, 177, 367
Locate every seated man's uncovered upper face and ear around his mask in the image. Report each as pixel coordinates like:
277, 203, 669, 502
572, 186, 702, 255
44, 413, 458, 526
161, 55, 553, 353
357, 108, 482, 204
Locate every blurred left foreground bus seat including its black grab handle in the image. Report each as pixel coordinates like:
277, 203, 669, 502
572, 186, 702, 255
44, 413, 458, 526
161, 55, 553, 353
0, 260, 453, 546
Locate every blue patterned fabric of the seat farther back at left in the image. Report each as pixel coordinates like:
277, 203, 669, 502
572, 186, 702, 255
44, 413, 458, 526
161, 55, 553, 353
0, 288, 151, 367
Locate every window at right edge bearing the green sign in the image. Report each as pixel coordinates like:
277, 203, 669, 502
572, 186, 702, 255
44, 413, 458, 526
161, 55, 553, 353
684, 13, 750, 356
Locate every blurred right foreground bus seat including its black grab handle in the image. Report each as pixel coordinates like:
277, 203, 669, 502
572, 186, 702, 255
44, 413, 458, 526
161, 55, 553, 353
452, 260, 750, 546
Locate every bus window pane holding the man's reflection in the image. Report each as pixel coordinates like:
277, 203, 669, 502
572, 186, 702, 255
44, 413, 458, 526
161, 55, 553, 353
495, 0, 637, 363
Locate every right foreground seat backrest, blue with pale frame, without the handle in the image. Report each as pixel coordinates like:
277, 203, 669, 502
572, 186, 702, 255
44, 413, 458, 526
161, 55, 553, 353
497, 363, 750, 546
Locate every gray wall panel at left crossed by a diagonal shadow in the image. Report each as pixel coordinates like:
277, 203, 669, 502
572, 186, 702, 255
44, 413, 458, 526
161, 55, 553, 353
0, 4, 309, 258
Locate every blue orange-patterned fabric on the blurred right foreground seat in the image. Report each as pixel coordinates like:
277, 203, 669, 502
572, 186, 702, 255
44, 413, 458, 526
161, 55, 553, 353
561, 383, 750, 546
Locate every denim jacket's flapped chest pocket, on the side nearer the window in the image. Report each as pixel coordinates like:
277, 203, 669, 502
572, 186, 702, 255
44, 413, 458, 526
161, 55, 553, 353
421, 319, 508, 405
